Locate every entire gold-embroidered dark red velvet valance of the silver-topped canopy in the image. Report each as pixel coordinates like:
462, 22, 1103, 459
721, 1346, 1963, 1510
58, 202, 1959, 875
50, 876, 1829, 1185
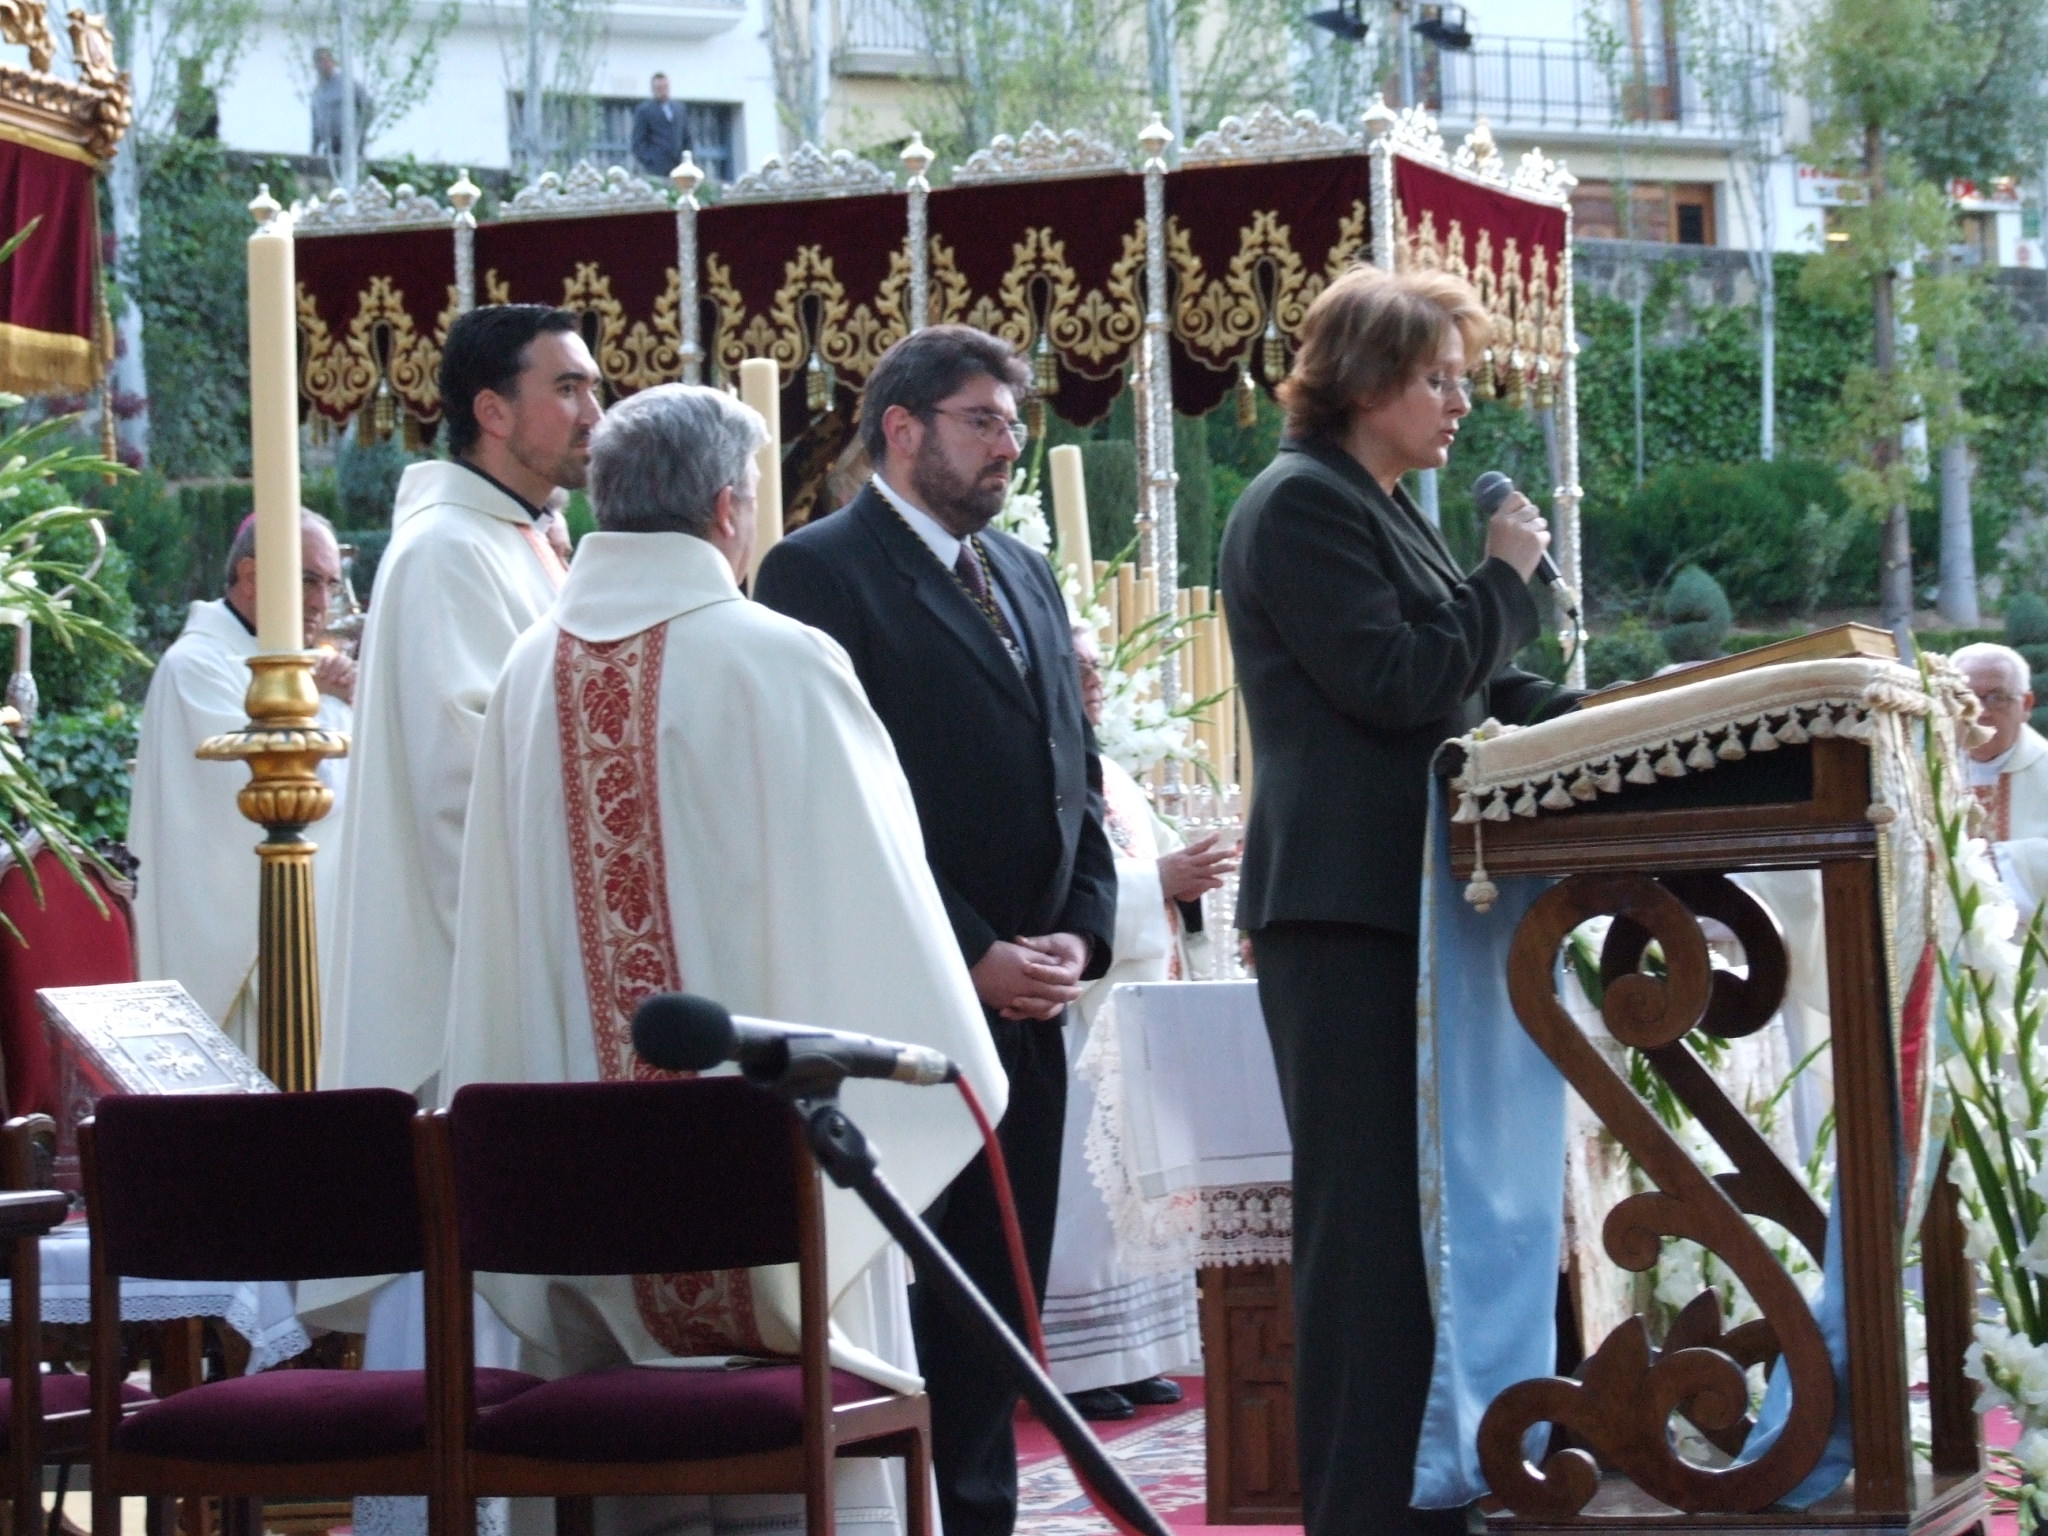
284, 154, 1567, 434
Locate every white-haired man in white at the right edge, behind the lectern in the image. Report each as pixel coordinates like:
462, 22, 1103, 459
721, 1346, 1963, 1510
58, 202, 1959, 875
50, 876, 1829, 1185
1952, 645, 2048, 920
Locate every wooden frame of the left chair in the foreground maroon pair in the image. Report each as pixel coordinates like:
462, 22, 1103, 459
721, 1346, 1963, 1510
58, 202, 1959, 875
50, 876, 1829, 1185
78, 1120, 446, 1536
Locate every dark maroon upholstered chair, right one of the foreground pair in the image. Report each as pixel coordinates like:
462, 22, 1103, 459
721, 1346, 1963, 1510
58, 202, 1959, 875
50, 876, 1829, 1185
420, 1077, 930, 1536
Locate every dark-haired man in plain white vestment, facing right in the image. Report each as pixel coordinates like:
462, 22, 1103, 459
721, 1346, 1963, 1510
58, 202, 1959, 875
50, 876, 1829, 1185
319, 305, 600, 1102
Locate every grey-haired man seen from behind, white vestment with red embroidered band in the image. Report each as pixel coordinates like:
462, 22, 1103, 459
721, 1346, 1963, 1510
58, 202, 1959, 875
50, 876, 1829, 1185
442, 385, 1006, 1536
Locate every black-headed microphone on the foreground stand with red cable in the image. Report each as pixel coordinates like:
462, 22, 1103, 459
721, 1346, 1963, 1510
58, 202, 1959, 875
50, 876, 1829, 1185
633, 991, 961, 1087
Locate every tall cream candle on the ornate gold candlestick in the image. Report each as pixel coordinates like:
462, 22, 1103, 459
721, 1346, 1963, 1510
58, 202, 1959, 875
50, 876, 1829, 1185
250, 186, 305, 655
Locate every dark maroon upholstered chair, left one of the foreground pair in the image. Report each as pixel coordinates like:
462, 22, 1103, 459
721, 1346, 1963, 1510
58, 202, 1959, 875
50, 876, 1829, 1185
80, 1087, 539, 1536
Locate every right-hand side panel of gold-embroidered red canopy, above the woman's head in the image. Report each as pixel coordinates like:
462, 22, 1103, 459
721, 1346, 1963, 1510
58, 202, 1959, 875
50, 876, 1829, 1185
1395, 156, 1571, 406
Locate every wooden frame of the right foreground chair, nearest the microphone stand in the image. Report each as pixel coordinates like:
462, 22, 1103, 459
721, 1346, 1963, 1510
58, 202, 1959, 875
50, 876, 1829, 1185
414, 1110, 932, 1536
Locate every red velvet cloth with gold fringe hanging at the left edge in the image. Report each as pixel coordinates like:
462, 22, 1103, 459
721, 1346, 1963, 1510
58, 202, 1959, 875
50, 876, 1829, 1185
0, 129, 102, 393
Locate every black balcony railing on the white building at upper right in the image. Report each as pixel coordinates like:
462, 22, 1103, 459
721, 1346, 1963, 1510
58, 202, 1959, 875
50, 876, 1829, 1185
1417, 37, 1774, 137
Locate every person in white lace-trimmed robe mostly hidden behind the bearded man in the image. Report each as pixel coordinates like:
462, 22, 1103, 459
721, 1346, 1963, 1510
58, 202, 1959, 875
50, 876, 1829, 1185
1042, 625, 1237, 1419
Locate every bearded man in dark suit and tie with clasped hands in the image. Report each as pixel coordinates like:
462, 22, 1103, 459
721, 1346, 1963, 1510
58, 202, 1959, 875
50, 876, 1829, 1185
754, 326, 1116, 1536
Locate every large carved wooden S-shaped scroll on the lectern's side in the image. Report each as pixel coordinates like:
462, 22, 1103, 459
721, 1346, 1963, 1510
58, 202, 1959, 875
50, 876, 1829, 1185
1479, 874, 1835, 1518
